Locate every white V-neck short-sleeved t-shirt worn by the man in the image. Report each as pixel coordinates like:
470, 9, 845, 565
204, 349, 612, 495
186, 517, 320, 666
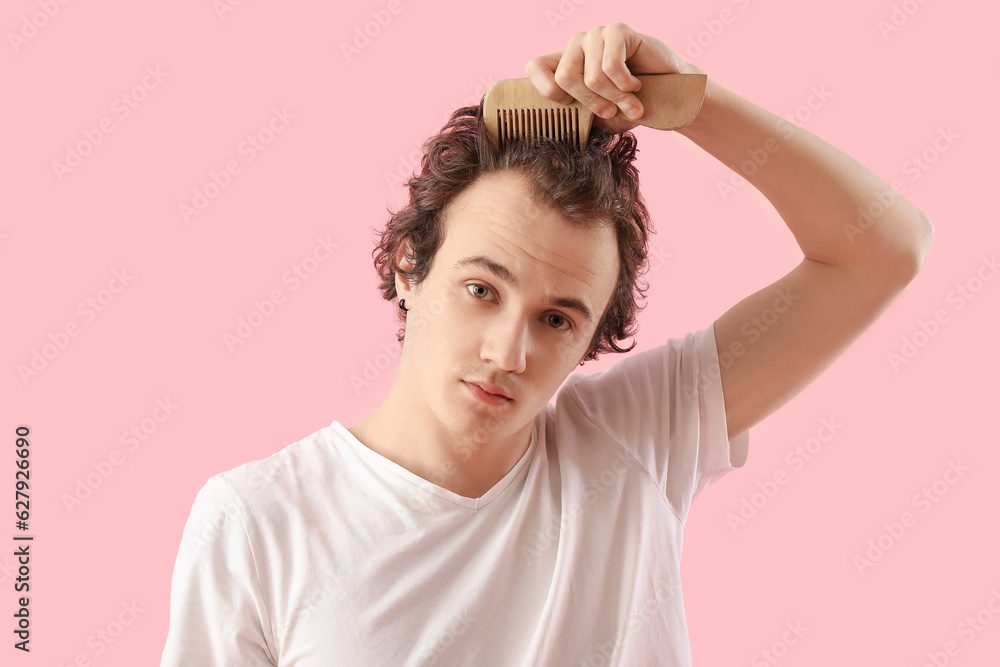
161, 325, 749, 667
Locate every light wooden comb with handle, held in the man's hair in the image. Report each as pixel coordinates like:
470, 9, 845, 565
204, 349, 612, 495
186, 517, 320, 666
483, 74, 708, 149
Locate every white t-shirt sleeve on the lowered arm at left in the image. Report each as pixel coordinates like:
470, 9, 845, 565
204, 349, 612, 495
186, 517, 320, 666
160, 476, 276, 667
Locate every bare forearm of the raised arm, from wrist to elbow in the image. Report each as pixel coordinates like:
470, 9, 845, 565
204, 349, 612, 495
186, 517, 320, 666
677, 77, 933, 272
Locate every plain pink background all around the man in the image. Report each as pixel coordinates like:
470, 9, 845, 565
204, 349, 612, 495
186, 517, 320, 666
0, 0, 1000, 667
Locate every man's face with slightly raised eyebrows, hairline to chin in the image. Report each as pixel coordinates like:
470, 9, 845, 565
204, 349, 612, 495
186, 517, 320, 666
396, 172, 619, 448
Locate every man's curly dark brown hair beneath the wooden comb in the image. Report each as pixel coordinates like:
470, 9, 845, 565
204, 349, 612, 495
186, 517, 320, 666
372, 102, 654, 365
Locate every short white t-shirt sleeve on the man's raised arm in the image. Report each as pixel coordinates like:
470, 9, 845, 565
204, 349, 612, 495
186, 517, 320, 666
565, 322, 750, 521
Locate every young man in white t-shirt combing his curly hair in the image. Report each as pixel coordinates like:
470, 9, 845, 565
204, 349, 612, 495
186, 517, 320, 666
162, 24, 933, 667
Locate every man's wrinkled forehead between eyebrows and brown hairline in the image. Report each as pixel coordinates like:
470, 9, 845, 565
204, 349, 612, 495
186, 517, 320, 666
439, 171, 618, 317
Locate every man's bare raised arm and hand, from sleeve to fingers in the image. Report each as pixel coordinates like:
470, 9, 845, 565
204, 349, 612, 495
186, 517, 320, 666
525, 23, 934, 444
